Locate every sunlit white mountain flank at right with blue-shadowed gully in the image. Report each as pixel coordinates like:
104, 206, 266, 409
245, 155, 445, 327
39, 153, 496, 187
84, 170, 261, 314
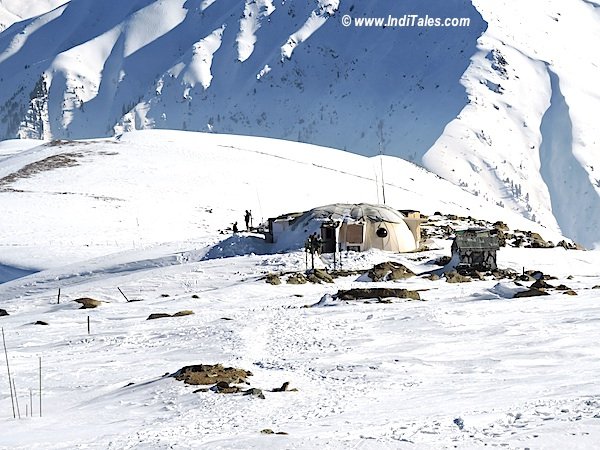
424, 0, 600, 246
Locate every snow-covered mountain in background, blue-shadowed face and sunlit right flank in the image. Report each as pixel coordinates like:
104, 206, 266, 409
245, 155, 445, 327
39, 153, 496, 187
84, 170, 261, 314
0, 0, 600, 246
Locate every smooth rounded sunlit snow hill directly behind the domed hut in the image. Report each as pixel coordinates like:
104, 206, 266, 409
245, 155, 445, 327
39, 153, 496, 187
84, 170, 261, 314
0, 130, 562, 269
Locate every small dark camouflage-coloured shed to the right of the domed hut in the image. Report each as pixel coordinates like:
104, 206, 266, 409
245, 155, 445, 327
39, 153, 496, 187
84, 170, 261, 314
452, 228, 500, 270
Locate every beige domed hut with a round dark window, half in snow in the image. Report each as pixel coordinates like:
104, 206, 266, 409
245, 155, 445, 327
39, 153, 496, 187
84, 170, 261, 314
265, 203, 423, 253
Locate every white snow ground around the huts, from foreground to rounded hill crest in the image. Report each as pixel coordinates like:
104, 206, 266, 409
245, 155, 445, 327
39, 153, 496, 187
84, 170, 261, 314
0, 131, 600, 449
